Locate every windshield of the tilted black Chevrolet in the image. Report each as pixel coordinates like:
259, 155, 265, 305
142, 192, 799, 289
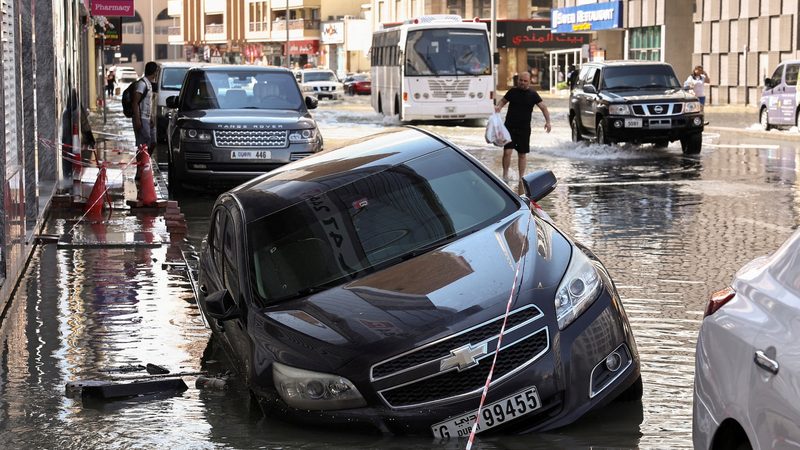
247, 149, 519, 304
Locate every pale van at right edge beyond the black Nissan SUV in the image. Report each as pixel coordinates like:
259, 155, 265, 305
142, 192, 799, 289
758, 59, 800, 130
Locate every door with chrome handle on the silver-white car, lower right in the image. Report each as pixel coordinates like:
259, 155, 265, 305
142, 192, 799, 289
748, 288, 800, 448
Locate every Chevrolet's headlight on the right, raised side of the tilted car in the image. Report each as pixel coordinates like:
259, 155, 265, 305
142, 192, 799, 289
555, 248, 603, 330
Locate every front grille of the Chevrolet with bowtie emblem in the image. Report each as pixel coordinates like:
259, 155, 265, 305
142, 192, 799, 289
371, 305, 550, 408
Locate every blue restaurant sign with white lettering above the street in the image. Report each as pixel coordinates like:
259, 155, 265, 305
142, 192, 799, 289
551, 1, 622, 33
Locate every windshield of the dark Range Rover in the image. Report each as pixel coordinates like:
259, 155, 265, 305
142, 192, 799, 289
181, 71, 303, 111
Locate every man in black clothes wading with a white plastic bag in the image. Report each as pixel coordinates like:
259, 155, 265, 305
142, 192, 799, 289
494, 72, 551, 183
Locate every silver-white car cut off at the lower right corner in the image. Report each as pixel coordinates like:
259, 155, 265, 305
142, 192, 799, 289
692, 230, 800, 449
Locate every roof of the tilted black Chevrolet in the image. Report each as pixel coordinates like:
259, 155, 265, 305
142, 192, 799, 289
228, 127, 449, 222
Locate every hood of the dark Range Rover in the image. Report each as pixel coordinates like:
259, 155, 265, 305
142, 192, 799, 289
179, 109, 314, 129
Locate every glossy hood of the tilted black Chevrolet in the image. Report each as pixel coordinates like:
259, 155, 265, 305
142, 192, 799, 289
256, 211, 572, 370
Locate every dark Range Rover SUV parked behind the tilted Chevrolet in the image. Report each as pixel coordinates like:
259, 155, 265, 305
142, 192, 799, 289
167, 65, 322, 193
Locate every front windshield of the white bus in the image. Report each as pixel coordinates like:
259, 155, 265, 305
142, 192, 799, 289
405, 29, 492, 76
